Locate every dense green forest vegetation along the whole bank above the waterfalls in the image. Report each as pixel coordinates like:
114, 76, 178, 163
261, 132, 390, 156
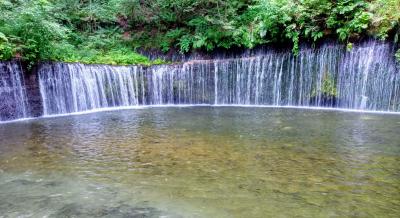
0, 0, 400, 64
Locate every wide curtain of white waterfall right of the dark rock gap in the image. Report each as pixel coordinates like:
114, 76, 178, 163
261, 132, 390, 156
39, 41, 400, 115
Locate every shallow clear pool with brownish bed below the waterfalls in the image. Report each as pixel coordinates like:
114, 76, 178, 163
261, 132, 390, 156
0, 107, 400, 217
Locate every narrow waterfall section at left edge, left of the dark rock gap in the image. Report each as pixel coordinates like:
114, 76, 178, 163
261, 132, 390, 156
0, 62, 29, 121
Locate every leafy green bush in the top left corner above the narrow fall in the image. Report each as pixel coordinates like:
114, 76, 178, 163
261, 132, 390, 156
0, 0, 67, 64
